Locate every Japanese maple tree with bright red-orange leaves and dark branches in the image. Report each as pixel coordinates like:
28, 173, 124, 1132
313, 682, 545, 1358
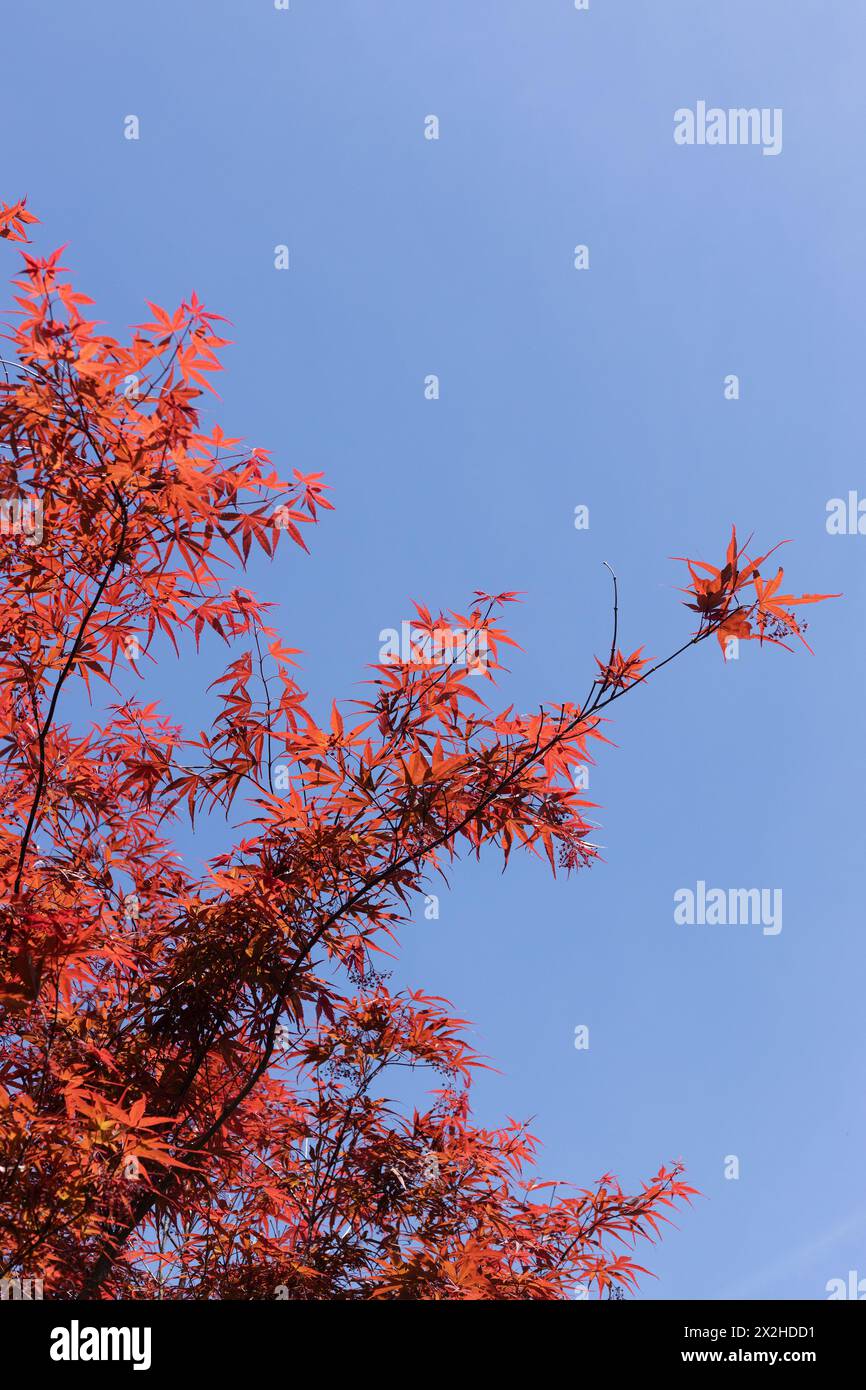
0, 203, 834, 1300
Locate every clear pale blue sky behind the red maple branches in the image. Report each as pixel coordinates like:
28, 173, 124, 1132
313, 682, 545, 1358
6, 0, 866, 1298
